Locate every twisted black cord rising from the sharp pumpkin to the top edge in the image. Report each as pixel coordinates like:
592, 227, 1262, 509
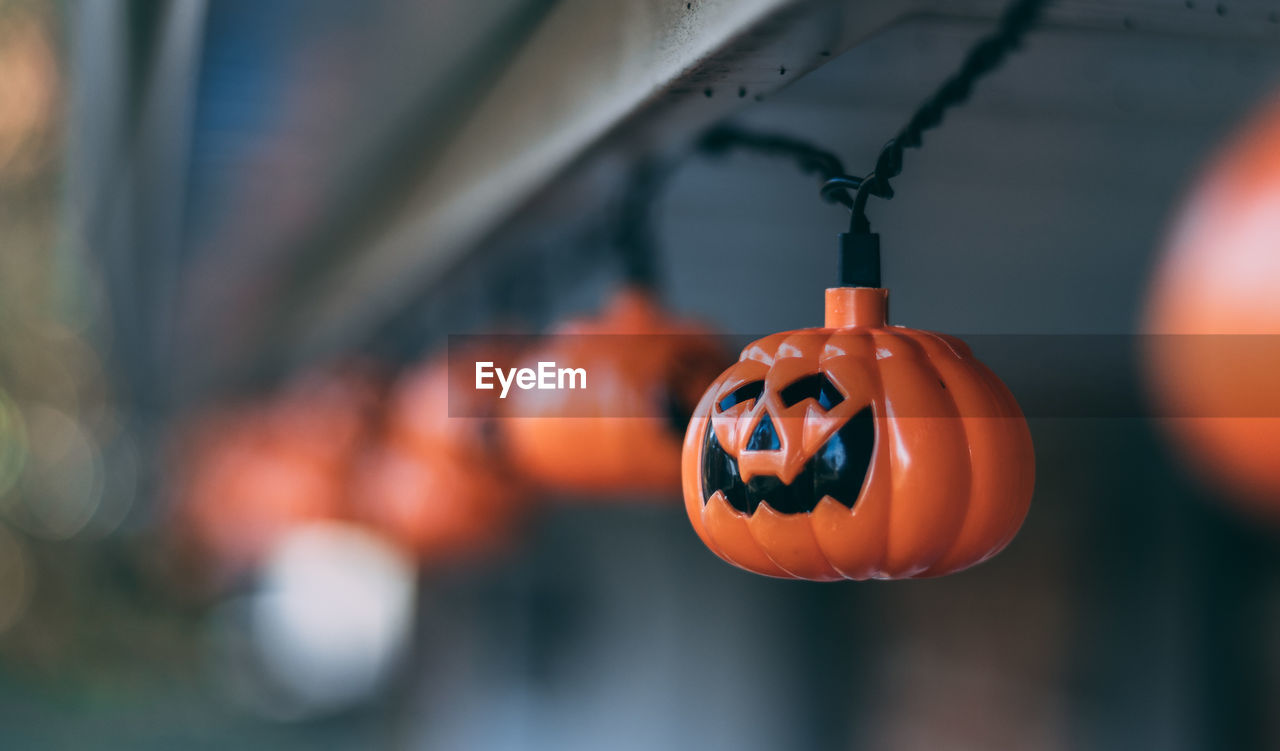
822, 0, 1047, 234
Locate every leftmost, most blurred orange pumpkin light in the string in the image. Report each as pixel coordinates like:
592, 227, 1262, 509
175, 371, 378, 573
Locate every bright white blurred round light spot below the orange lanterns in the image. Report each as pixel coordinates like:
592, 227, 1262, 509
250, 522, 415, 714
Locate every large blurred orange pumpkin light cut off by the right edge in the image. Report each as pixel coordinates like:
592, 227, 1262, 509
1144, 92, 1280, 519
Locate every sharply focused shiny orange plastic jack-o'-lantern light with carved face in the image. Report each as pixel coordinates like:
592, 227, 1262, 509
684, 288, 1034, 580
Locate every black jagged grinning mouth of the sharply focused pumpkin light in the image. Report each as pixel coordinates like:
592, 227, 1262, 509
701, 407, 876, 516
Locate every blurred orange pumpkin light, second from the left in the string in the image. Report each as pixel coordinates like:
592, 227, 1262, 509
353, 356, 526, 562
